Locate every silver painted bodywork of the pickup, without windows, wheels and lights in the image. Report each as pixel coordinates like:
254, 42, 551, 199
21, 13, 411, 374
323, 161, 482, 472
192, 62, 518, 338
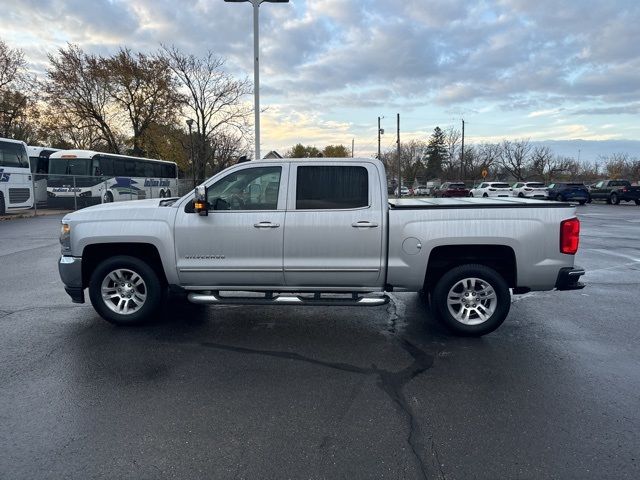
60, 159, 575, 292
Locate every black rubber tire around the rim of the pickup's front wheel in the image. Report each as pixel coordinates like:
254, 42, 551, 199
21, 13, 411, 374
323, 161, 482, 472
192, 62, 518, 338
89, 255, 163, 325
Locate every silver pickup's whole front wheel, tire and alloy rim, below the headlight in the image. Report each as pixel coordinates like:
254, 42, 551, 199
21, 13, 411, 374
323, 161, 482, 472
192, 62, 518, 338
89, 255, 162, 325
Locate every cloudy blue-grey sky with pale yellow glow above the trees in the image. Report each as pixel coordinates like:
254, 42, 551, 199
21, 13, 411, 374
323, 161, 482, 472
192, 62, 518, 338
5, 0, 640, 157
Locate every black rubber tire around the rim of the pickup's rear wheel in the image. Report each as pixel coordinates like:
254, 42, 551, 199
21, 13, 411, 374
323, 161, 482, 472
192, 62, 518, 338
431, 264, 511, 337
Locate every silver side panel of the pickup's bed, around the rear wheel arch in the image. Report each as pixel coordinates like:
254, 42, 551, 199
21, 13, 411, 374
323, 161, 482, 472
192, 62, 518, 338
387, 198, 575, 290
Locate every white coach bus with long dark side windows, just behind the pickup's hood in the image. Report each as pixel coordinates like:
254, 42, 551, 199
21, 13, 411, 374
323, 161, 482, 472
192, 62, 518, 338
47, 150, 178, 206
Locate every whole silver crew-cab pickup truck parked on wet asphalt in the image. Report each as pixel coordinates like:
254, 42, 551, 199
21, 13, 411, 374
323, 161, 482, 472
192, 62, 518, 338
59, 159, 584, 335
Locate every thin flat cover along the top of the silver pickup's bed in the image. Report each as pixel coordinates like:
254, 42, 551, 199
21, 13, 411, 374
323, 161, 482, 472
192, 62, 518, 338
389, 197, 570, 210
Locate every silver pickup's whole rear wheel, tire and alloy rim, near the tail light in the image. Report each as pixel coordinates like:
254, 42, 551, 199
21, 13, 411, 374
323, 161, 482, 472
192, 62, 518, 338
431, 264, 511, 337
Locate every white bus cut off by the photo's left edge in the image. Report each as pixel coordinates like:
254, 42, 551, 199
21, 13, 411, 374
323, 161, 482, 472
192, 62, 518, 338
0, 138, 33, 215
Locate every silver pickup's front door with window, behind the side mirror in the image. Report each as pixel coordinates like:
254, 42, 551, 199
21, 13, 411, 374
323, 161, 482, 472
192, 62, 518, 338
175, 162, 288, 287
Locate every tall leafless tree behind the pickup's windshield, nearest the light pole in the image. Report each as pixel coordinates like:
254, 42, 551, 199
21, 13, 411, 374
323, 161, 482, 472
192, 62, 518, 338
158, 46, 252, 178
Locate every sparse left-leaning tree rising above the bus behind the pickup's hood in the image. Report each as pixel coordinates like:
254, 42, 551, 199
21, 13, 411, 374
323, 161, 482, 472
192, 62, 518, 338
44, 44, 122, 153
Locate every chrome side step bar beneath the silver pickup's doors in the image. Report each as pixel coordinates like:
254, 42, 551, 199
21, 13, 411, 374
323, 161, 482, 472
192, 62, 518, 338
187, 292, 389, 307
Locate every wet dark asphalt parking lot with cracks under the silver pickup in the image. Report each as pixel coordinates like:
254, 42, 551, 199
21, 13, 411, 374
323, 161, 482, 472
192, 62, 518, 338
0, 204, 640, 479
